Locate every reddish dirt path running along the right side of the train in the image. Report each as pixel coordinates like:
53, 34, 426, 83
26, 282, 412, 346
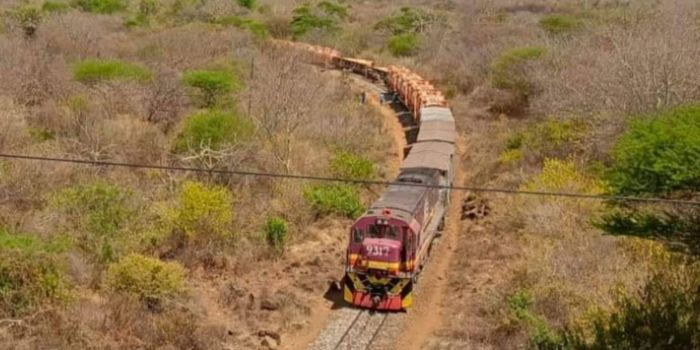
395, 132, 466, 350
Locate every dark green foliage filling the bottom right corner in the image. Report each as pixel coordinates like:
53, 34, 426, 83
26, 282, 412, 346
538, 266, 700, 350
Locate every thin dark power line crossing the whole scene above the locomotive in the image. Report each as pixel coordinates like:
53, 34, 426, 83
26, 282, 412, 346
0, 153, 700, 206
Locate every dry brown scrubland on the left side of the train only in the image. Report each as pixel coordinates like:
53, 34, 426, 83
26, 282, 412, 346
0, 0, 393, 349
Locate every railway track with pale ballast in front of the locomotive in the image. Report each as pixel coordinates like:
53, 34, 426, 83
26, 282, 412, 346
309, 309, 392, 350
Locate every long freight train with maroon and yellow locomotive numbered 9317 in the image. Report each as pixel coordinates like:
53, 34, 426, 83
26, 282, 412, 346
286, 43, 457, 311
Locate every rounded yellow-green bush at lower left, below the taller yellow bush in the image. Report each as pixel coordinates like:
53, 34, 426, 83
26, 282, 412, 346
104, 254, 185, 306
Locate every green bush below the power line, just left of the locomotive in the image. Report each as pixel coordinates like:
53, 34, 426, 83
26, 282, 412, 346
304, 184, 365, 219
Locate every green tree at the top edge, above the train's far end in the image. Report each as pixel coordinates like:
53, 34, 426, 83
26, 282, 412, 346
291, 1, 348, 39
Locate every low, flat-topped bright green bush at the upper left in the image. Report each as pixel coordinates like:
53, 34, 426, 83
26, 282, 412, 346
73, 59, 152, 84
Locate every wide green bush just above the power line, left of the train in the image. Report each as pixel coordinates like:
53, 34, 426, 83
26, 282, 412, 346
175, 110, 253, 153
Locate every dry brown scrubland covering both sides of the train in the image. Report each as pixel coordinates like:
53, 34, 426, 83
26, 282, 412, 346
0, 0, 700, 349
